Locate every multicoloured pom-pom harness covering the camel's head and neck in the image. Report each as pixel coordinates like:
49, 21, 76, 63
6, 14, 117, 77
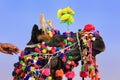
13, 30, 100, 80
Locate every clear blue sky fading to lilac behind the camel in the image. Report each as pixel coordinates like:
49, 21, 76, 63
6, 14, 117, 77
0, 0, 120, 80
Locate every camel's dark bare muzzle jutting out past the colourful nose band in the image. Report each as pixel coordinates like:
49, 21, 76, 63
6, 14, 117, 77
93, 35, 105, 55
